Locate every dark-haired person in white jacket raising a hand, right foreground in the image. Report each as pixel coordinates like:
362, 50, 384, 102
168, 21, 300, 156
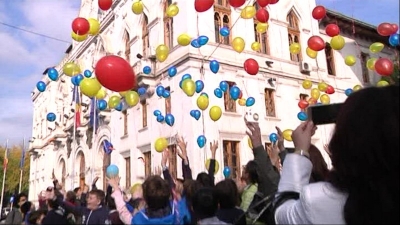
275, 86, 399, 224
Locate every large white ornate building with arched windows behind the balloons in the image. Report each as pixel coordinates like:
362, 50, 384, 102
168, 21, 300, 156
30, 0, 393, 204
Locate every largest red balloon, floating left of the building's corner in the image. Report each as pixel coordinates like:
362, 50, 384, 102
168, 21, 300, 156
94, 55, 136, 92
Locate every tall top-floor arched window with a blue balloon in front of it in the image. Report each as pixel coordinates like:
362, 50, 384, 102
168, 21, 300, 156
214, 0, 231, 45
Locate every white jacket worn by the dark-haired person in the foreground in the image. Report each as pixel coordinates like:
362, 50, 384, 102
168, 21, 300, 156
275, 154, 347, 224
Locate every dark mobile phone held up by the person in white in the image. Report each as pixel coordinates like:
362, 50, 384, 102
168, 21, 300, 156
307, 103, 343, 125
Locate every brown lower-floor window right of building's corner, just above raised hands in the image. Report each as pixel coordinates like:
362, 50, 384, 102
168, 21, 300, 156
223, 140, 241, 179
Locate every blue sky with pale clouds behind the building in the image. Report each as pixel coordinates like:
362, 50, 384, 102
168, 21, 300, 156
0, 0, 399, 145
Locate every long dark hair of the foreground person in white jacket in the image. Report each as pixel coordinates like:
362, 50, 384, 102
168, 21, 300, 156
329, 86, 399, 224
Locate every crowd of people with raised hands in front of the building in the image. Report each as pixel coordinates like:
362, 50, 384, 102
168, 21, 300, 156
6, 86, 399, 225
